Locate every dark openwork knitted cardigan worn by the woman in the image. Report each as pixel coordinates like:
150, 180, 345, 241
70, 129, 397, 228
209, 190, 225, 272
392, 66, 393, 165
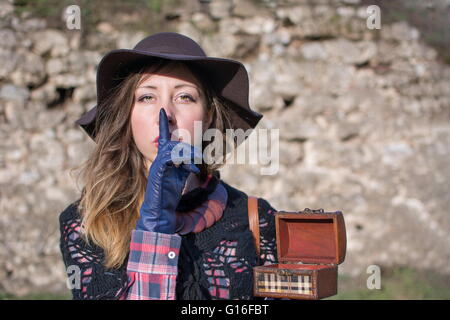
59, 171, 277, 300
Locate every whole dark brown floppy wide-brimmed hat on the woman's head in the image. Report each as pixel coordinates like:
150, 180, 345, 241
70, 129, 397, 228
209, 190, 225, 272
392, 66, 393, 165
75, 32, 263, 141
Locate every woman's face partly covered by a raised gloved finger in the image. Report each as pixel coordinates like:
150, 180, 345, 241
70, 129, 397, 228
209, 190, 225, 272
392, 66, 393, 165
131, 65, 209, 167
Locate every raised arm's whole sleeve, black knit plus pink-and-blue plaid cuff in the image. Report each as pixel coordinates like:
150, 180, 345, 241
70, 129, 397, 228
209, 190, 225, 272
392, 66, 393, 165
59, 203, 181, 300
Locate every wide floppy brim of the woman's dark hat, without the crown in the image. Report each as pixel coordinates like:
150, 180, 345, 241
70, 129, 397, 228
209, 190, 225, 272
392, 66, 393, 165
75, 49, 263, 140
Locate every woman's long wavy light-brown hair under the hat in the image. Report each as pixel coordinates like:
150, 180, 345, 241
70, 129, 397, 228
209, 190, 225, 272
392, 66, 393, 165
70, 58, 236, 268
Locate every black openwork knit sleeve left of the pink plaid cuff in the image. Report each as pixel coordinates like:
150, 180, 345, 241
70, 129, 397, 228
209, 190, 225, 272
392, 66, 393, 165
59, 202, 128, 300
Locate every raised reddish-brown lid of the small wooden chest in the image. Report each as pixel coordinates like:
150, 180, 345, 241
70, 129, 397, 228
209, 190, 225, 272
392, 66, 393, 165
275, 208, 347, 264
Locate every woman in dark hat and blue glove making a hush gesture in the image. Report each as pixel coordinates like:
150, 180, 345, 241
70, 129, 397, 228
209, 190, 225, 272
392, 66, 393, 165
59, 32, 276, 299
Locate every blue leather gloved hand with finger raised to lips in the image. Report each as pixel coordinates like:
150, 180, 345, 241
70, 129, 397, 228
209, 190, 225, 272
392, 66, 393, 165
136, 109, 202, 234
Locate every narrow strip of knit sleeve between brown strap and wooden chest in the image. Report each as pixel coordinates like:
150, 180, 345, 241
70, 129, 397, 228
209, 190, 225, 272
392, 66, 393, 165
258, 198, 277, 265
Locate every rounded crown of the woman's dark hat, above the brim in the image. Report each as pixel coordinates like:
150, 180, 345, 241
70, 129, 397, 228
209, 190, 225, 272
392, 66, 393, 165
133, 32, 206, 57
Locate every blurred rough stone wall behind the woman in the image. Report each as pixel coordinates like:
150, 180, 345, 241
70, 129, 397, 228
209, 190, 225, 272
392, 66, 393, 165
0, 0, 450, 298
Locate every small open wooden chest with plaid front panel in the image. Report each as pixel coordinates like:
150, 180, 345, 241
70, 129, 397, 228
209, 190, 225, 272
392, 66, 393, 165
253, 208, 347, 299
